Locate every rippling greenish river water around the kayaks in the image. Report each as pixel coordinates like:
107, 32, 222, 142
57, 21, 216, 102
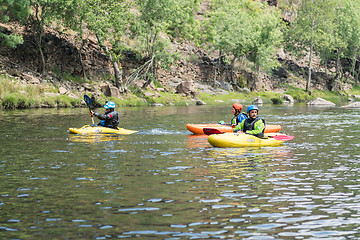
0, 105, 360, 239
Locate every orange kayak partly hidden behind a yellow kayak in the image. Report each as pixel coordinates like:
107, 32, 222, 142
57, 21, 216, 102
186, 123, 281, 134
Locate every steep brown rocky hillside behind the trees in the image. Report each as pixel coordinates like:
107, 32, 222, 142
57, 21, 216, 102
0, 1, 351, 109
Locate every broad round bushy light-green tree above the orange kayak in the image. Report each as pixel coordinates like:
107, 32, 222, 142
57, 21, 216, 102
205, 0, 282, 88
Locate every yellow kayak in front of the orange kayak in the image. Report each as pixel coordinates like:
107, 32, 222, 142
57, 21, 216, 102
208, 133, 293, 147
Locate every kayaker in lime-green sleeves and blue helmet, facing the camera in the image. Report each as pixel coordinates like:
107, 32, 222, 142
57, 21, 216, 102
233, 105, 265, 137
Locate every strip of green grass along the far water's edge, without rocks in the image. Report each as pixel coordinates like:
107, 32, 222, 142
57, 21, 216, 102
0, 75, 360, 109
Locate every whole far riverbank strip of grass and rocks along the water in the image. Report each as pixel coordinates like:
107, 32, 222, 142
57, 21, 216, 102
0, 74, 360, 110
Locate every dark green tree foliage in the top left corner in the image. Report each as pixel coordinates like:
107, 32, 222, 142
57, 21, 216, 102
0, 0, 30, 48
